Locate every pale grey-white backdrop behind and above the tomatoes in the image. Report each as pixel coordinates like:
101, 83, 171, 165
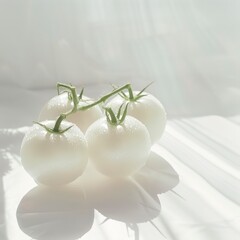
0, 0, 240, 125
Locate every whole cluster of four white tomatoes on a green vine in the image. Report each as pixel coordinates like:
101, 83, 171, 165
20, 84, 166, 186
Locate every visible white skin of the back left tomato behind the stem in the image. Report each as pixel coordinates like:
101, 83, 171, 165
39, 93, 103, 133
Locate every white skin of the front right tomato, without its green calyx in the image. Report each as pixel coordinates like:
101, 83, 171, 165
86, 116, 151, 177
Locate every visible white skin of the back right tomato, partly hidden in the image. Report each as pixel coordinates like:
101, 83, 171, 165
107, 91, 167, 144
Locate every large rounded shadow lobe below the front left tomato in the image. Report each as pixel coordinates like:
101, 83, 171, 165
16, 186, 94, 240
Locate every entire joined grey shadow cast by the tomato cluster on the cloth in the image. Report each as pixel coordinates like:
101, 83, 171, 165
17, 152, 179, 240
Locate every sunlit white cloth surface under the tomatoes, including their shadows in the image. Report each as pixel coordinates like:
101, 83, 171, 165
0, 116, 240, 240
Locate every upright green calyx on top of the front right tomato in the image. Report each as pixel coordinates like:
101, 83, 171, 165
104, 103, 128, 126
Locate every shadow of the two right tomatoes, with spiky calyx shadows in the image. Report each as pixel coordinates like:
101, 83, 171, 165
83, 152, 179, 240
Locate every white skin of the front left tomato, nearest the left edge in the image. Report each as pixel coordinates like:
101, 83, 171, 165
20, 121, 88, 186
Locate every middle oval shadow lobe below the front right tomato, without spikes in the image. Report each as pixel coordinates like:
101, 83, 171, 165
91, 179, 161, 224
